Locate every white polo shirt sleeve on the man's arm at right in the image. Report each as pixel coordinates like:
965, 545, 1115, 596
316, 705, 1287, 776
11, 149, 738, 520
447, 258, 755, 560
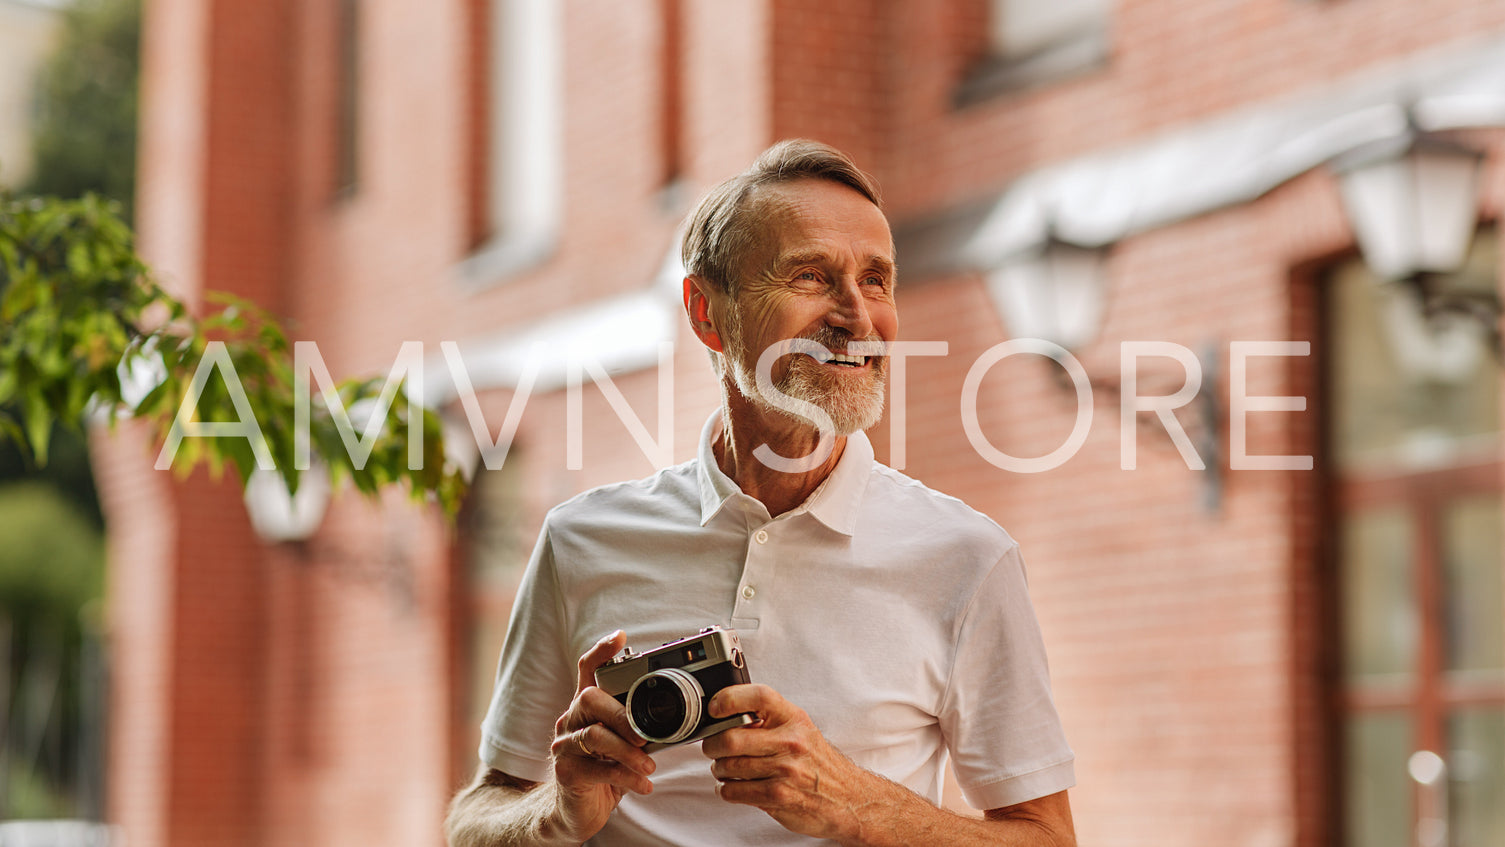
941, 545, 1076, 809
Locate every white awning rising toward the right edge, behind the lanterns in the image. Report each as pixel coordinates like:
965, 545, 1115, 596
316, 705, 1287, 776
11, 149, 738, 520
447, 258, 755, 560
957, 36, 1505, 269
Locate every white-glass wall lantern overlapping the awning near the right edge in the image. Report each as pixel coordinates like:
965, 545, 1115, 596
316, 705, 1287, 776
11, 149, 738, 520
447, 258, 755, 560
1332, 126, 1484, 280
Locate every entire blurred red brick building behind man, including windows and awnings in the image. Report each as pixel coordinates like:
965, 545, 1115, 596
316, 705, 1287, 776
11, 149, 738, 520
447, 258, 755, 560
96, 0, 1505, 847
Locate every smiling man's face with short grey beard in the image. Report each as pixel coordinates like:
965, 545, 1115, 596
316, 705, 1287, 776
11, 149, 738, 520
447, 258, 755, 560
725, 179, 898, 435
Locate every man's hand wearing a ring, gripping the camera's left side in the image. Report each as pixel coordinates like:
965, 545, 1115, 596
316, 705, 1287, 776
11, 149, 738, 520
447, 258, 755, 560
549, 629, 653, 841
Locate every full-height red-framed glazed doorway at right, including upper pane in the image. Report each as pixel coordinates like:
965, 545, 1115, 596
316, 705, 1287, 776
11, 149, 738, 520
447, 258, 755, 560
1324, 233, 1505, 847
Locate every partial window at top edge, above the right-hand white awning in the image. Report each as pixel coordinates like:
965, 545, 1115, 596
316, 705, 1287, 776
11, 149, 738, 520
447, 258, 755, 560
959, 0, 1112, 102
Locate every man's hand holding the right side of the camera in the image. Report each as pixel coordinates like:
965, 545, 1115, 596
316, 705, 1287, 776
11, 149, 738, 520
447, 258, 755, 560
701, 685, 871, 839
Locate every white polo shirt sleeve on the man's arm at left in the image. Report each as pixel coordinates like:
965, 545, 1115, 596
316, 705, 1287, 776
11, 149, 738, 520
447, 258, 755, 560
480, 522, 576, 782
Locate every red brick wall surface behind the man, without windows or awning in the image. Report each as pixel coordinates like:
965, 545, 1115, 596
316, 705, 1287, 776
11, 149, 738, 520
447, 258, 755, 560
98, 0, 1505, 847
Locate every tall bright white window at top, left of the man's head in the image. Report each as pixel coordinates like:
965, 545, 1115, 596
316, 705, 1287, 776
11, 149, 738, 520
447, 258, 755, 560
465, 0, 563, 283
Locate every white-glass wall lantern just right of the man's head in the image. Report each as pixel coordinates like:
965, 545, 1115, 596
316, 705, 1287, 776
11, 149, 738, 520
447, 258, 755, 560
987, 235, 1106, 351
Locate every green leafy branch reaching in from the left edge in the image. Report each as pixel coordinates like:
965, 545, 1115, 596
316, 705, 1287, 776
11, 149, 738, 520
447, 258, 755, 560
0, 196, 465, 515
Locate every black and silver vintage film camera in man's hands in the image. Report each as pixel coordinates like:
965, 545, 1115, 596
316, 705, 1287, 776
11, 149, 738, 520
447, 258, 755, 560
596, 626, 757, 752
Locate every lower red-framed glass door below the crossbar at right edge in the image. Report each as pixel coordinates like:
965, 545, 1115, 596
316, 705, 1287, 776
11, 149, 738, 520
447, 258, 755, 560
1336, 475, 1505, 847
